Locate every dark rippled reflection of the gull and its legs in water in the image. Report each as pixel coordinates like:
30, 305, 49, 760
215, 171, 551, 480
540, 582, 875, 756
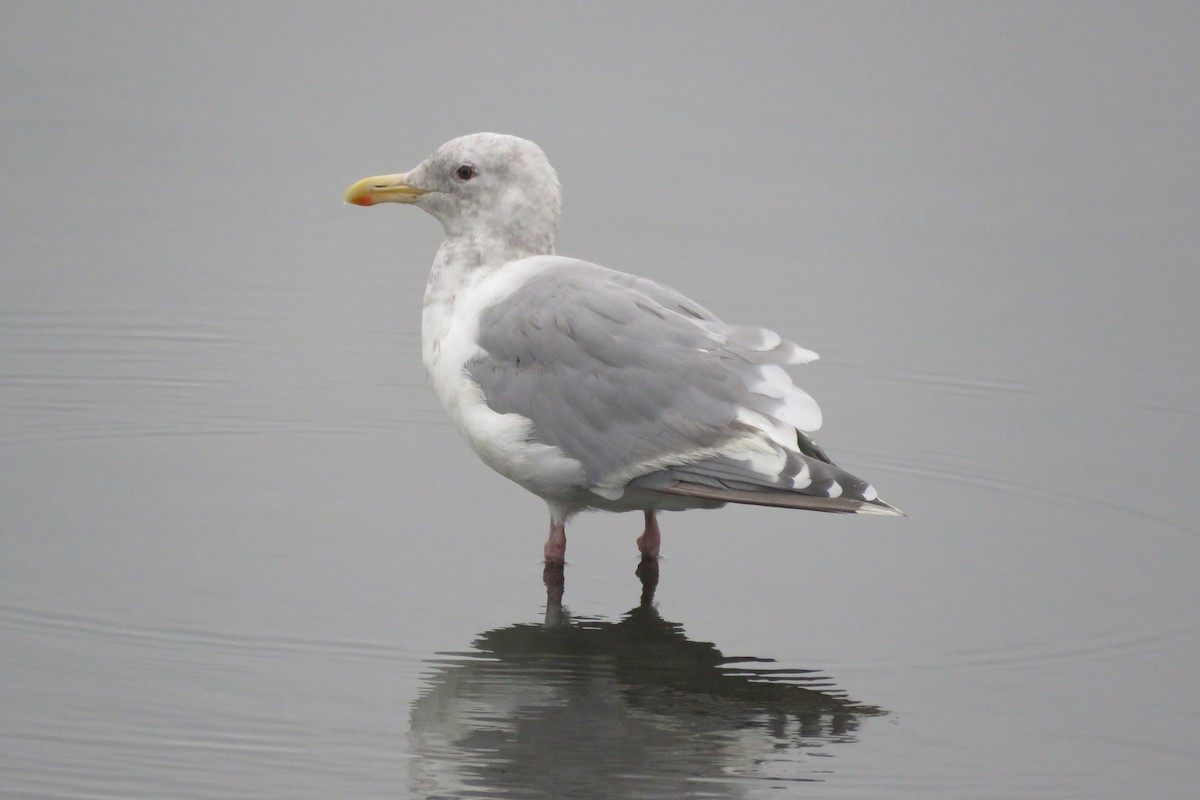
409, 560, 882, 798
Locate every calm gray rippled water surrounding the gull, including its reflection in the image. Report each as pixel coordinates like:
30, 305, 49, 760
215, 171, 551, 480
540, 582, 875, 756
0, 2, 1200, 798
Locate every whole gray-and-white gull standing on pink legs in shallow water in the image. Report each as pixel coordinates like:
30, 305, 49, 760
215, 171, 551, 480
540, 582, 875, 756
346, 133, 900, 565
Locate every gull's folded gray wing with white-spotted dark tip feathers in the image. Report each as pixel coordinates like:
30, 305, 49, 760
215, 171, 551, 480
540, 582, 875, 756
466, 259, 892, 511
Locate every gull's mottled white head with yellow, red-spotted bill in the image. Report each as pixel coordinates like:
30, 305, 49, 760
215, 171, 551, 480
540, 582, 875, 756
346, 133, 562, 255
